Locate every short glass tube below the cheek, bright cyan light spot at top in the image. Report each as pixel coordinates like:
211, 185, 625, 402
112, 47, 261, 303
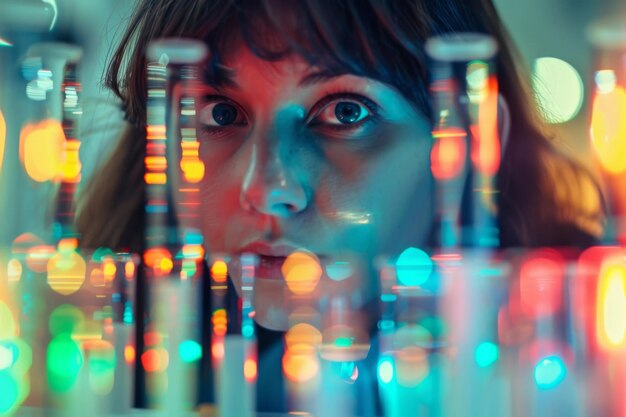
377, 248, 449, 417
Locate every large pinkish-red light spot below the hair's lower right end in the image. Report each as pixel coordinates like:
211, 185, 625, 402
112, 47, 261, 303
520, 255, 564, 316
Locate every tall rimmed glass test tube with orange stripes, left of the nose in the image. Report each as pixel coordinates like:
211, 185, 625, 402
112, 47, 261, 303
137, 39, 206, 415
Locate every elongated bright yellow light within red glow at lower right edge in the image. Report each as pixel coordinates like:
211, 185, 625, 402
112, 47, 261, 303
597, 259, 626, 349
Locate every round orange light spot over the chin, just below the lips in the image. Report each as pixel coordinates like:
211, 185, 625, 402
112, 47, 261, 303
281, 251, 322, 295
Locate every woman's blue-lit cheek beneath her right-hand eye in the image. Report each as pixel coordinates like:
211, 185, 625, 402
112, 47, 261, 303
316, 127, 433, 251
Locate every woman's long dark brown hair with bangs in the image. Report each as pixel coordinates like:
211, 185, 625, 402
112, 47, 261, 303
77, 0, 603, 250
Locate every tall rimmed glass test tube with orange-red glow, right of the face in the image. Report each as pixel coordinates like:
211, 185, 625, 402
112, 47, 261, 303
426, 33, 501, 247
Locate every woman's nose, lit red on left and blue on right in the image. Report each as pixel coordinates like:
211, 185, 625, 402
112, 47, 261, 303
240, 110, 309, 218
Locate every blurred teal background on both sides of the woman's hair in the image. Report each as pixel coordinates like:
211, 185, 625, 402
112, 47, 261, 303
0, 0, 626, 245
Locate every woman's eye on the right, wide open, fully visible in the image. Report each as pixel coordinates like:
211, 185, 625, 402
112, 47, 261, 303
308, 93, 379, 130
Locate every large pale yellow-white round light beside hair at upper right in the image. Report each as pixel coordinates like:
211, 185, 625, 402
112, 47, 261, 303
533, 57, 584, 123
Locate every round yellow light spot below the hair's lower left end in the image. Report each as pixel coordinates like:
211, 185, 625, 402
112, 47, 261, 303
48, 252, 87, 295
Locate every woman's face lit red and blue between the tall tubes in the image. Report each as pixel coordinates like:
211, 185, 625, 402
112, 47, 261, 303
197, 45, 433, 326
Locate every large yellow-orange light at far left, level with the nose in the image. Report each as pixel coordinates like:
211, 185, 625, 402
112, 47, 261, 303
20, 119, 65, 182
